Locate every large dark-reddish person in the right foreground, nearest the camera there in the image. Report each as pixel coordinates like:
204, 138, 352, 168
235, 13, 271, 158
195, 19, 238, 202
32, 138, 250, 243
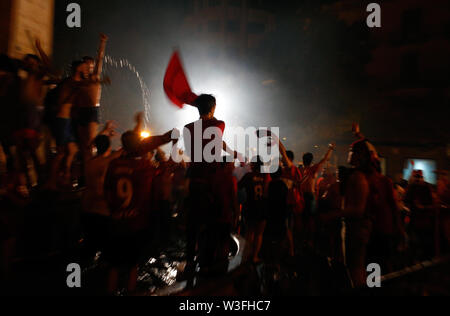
321, 139, 404, 287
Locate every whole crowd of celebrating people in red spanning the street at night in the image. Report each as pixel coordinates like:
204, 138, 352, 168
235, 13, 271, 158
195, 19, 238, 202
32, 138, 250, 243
0, 35, 450, 293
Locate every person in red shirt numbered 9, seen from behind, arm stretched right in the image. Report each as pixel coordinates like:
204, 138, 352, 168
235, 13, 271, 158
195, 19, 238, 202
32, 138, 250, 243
105, 127, 172, 293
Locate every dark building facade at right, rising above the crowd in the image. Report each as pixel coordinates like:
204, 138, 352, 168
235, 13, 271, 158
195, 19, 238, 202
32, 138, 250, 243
326, 0, 450, 182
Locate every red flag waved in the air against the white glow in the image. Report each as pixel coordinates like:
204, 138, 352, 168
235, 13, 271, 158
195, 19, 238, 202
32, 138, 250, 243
164, 51, 197, 109
